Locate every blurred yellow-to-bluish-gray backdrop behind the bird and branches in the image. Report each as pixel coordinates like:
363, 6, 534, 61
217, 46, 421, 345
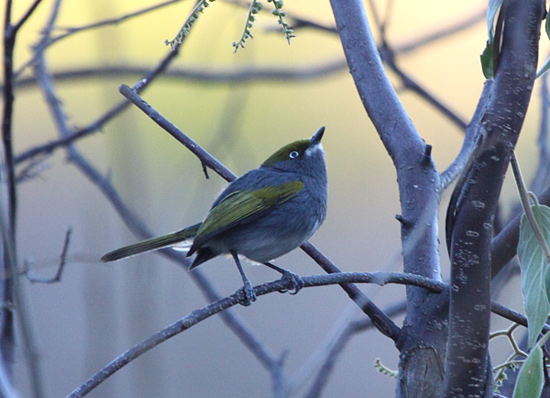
0, 0, 548, 397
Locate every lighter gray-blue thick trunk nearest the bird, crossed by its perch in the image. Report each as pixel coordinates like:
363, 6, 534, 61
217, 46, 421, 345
331, 0, 446, 396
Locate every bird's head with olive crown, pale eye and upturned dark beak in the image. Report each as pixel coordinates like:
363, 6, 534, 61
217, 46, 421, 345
262, 127, 326, 176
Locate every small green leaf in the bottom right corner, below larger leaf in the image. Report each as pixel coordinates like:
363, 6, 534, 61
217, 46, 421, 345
513, 345, 544, 398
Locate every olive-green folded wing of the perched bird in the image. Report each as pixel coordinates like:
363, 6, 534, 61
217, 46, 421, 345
189, 181, 304, 254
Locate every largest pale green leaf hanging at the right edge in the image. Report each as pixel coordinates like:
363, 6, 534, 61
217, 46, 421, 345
518, 206, 550, 347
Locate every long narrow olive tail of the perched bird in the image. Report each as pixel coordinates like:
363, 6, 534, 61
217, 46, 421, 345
101, 223, 201, 262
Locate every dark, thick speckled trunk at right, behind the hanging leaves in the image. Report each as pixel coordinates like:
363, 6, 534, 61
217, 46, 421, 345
445, 0, 544, 397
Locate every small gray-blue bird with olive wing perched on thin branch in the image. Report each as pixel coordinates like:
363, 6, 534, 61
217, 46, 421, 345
101, 127, 327, 305
